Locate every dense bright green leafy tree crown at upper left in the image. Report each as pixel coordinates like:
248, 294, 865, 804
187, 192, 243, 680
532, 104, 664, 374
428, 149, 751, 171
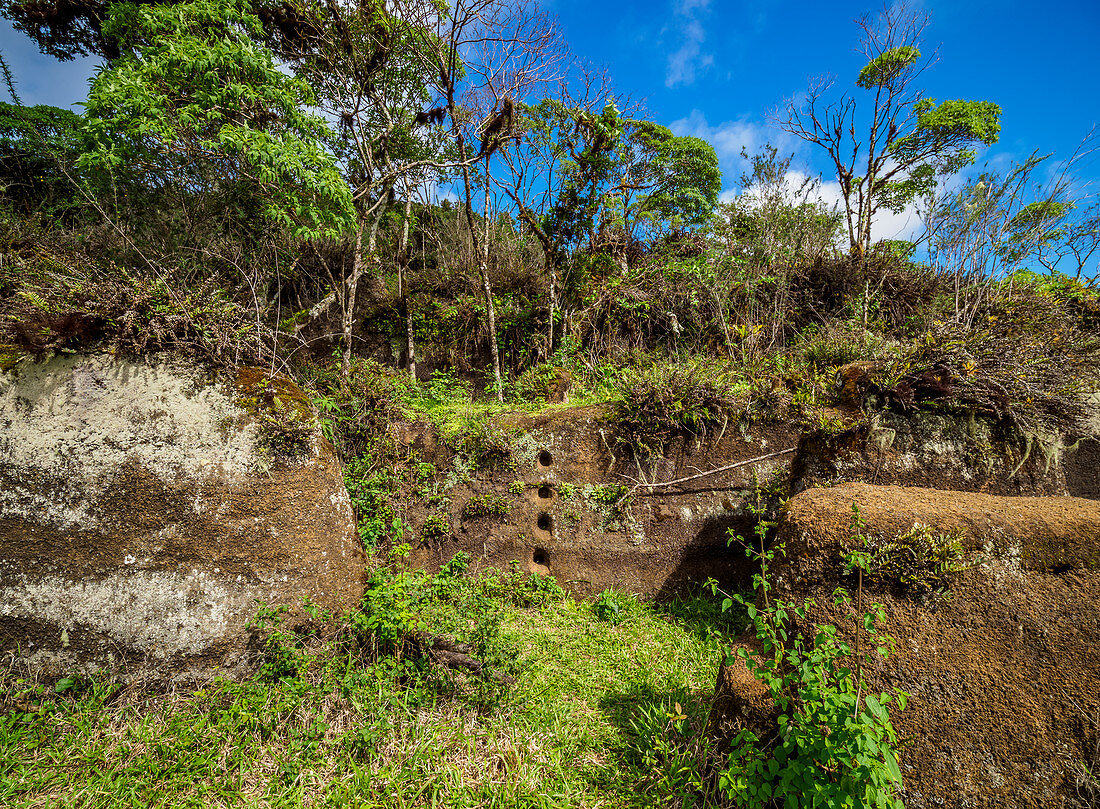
80, 0, 352, 238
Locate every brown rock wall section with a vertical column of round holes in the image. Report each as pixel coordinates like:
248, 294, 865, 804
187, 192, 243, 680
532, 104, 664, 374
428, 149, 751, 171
411, 407, 799, 597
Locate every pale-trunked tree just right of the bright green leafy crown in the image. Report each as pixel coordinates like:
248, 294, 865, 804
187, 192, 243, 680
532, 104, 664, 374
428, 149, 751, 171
282, 0, 453, 371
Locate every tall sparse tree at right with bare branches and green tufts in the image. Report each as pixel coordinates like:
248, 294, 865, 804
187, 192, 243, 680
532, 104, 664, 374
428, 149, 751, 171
773, 4, 1001, 255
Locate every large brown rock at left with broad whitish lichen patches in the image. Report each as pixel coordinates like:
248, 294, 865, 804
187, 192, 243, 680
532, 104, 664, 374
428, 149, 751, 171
0, 354, 363, 676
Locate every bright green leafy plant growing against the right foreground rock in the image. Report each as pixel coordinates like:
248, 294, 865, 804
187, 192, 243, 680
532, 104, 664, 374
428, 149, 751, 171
718, 506, 906, 809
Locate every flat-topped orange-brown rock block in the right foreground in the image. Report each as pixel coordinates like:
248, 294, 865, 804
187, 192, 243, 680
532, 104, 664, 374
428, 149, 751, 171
756, 483, 1100, 809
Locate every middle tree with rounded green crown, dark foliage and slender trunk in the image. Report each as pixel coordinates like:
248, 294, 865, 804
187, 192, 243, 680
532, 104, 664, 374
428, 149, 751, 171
497, 88, 722, 357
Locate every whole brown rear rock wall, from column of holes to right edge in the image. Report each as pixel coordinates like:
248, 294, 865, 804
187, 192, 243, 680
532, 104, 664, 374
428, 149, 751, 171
400, 394, 1097, 597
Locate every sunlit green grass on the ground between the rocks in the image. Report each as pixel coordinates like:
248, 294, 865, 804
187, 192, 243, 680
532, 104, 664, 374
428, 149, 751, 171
0, 577, 748, 809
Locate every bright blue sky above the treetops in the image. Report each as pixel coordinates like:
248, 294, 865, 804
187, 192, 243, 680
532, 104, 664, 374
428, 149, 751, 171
0, 0, 1100, 236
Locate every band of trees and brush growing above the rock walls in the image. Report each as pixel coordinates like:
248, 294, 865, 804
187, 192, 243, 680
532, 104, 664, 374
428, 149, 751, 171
0, 0, 1100, 397
